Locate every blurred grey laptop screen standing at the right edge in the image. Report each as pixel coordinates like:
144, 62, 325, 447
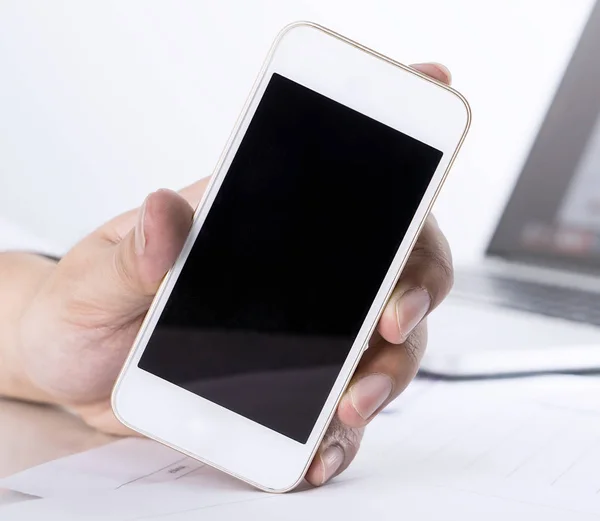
488, 2, 600, 272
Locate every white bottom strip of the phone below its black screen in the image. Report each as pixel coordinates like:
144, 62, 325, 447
112, 368, 314, 492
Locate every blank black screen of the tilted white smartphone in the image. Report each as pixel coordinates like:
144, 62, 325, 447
139, 74, 442, 443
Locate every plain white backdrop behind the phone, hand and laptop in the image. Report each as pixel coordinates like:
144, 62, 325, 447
0, 0, 593, 262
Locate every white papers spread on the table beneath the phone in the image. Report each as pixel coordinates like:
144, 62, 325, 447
0, 377, 600, 521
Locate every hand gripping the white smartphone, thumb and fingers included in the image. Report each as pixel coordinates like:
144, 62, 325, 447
18, 64, 452, 485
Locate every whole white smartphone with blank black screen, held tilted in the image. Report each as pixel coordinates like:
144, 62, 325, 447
112, 22, 470, 492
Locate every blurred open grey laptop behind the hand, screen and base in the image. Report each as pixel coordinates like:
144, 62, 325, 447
423, 3, 600, 377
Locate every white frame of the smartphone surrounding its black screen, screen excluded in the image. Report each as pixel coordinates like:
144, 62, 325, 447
112, 22, 471, 492
